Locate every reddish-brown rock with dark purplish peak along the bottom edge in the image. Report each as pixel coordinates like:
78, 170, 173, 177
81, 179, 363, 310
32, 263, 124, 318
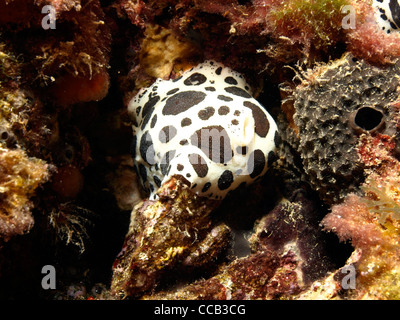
143, 189, 335, 300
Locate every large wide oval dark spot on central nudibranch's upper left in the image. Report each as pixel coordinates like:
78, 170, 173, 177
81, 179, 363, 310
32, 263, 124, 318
162, 91, 206, 115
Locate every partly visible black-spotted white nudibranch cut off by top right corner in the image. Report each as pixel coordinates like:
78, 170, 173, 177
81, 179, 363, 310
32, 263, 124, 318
372, 0, 400, 33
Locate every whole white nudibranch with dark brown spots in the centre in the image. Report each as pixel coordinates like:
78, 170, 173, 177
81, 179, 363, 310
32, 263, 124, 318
128, 61, 279, 200
